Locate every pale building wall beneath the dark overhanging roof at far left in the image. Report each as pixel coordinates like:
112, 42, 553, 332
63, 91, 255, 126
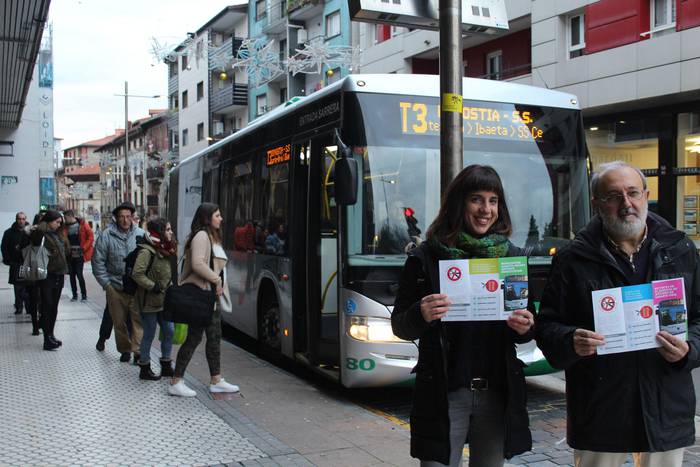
0, 67, 45, 230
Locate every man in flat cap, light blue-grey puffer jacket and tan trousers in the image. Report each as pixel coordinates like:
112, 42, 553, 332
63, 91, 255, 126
92, 201, 144, 364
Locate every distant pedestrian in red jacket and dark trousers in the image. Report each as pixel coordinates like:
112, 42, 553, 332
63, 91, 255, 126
63, 209, 95, 302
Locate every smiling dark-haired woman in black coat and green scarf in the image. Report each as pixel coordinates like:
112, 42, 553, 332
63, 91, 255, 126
391, 165, 533, 467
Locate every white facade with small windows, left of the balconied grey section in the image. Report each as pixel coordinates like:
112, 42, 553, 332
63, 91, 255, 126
178, 31, 209, 160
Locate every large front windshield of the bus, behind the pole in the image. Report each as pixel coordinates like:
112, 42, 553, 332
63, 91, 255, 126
345, 94, 589, 266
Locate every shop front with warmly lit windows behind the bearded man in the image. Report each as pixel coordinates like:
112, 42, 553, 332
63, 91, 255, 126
584, 107, 700, 249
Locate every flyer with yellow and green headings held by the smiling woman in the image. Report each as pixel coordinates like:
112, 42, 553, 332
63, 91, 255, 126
439, 256, 528, 321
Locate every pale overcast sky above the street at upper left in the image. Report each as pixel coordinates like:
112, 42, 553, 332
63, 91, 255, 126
49, 0, 247, 148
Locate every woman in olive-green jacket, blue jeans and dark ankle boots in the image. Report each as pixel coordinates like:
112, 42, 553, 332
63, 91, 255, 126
131, 218, 177, 381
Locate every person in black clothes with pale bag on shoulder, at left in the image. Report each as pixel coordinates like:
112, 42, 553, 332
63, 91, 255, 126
31, 209, 70, 350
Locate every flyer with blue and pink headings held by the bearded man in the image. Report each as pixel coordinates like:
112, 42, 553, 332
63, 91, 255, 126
591, 278, 688, 355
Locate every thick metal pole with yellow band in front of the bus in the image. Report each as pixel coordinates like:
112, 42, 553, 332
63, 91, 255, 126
440, 0, 464, 193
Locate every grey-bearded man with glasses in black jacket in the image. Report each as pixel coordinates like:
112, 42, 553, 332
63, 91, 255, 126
535, 162, 700, 467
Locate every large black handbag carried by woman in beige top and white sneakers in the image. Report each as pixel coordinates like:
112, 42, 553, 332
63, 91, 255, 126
163, 241, 216, 328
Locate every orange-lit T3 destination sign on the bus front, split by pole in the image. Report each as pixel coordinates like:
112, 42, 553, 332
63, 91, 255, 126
399, 101, 544, 142
